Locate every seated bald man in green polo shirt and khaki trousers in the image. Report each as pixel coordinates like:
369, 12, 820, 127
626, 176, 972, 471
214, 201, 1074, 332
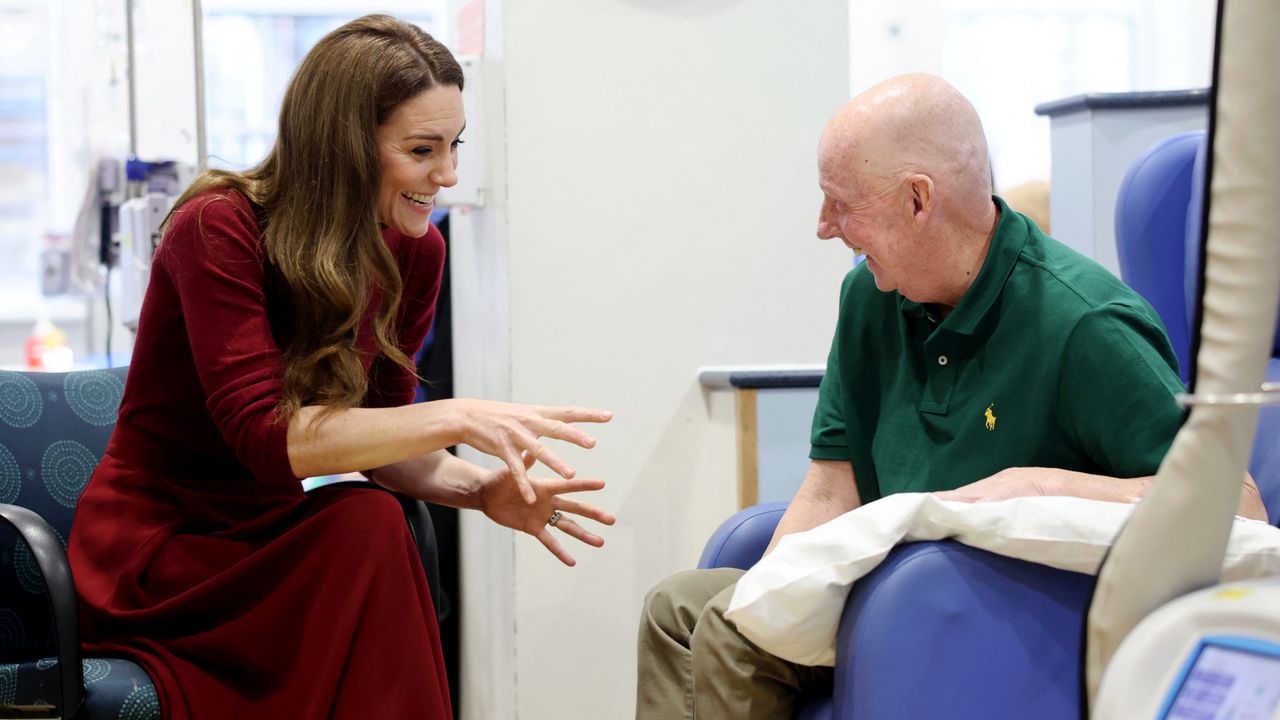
636, 74, 1266, 720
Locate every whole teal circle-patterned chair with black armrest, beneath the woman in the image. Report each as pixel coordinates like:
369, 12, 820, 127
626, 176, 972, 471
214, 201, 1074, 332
0, 368, 160, 720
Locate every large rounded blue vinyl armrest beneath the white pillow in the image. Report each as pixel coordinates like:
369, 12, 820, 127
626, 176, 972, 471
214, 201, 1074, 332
833, 541, 1094, 720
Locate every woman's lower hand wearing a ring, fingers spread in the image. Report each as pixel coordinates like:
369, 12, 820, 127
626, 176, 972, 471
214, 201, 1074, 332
479, 454, 614, 568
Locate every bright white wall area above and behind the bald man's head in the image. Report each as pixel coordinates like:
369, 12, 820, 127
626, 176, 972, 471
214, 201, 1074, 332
849, 0, 1216, 192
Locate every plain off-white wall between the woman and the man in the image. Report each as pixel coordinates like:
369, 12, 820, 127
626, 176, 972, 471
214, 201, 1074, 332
452, 0, 850, 719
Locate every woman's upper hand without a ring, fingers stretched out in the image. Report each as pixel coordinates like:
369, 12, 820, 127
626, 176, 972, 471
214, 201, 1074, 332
447, 398, 613, 505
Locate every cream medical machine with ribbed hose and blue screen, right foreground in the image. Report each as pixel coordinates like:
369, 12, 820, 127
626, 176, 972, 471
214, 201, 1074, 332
1085, 0, 1280, 720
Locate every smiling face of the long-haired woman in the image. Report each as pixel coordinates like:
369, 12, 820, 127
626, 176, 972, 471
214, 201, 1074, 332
378, 85, 466, 237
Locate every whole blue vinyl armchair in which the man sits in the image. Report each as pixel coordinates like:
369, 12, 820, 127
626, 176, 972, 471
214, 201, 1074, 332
699, 126, 1280, 720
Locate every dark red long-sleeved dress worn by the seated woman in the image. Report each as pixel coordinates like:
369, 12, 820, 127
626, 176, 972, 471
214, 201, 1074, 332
69, 192, 452, 720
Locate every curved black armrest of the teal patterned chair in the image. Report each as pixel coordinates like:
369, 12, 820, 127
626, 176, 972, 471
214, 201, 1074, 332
0, 503, 84, 719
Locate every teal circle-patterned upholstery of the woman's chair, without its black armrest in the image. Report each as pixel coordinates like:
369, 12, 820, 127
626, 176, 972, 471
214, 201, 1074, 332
0, 368, 160, 720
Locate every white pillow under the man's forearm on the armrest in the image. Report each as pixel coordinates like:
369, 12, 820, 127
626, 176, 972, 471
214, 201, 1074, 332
726, 493, 1280, 665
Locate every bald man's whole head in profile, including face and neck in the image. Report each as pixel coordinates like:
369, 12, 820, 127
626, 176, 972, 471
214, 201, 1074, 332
818, 74, 998, 304
